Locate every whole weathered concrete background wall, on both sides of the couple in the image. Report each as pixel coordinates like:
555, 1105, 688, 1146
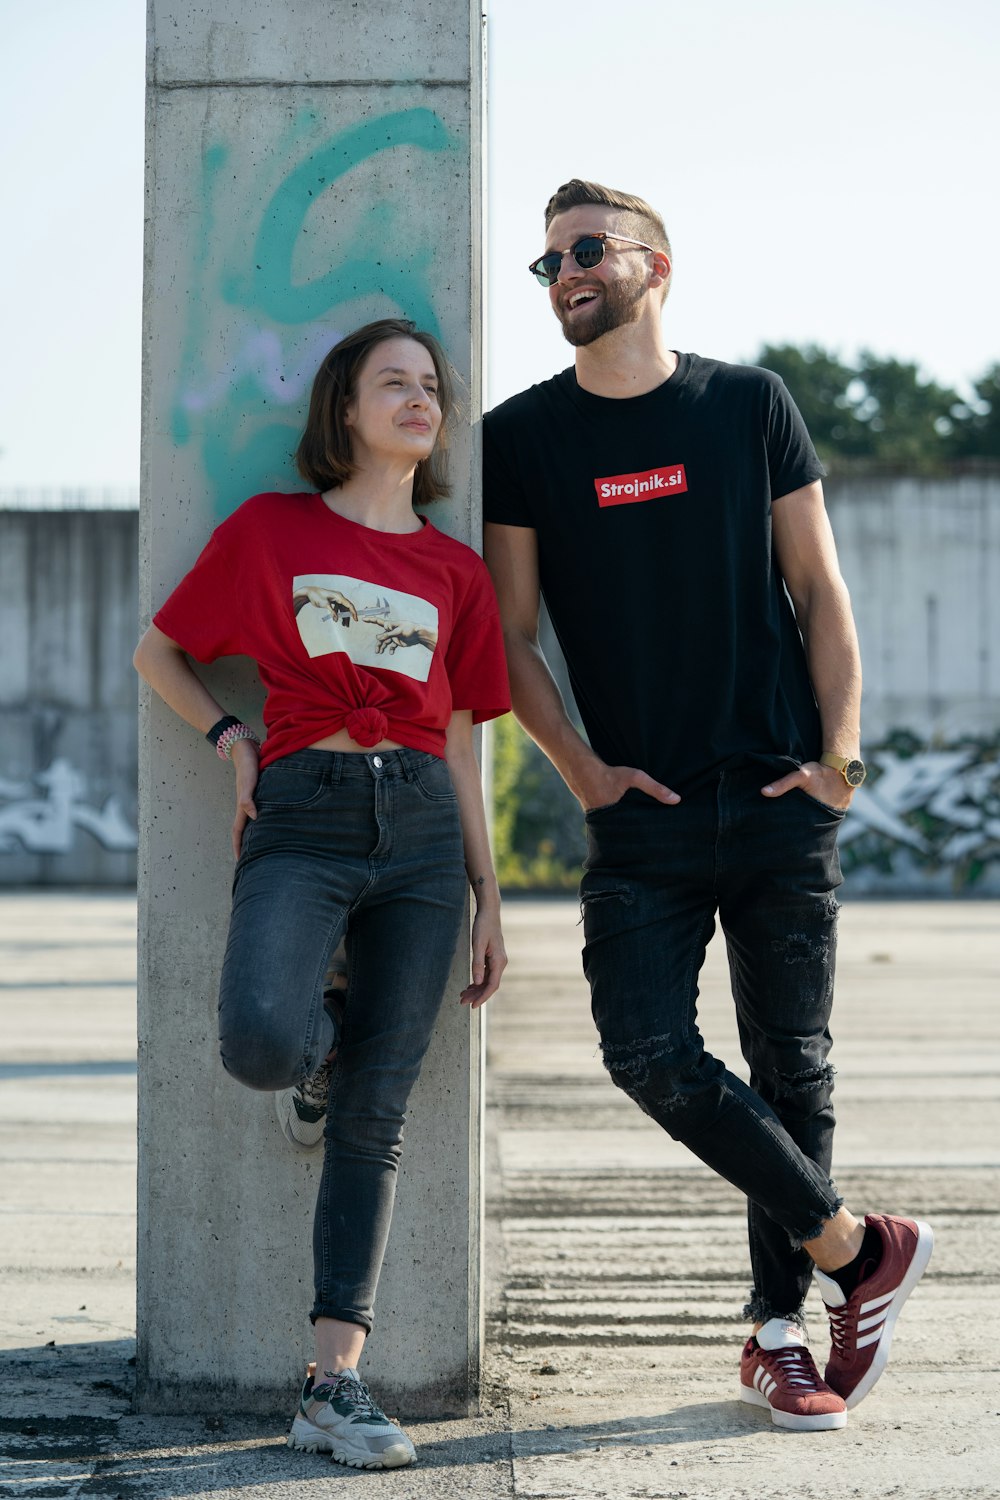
7, 474, 1000, 894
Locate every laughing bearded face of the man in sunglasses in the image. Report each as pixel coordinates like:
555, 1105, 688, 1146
546, 204, 651, 348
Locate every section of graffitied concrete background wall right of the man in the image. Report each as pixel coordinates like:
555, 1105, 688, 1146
826, 474, 1000, 896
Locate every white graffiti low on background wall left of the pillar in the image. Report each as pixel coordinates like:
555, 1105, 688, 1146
0, 758, 138, 854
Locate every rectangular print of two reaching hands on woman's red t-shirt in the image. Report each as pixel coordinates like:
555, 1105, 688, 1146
292, 573, 438, 683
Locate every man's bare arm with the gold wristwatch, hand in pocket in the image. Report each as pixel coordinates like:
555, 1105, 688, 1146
763, 480, 861, 807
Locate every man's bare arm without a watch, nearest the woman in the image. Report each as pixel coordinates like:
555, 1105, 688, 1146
483, 524, 681, 810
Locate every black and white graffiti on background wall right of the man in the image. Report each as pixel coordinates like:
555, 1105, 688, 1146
840, 731, 1000, 891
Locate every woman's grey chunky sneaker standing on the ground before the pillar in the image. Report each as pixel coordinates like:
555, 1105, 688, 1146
288, 1370, 417, 1469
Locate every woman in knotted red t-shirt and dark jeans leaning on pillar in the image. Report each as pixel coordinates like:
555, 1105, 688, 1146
135, 320, 510, 1469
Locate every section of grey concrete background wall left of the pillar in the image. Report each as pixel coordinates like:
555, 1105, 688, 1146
0, 509, 138, 885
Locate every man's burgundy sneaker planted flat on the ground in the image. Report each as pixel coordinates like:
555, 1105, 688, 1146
739, 1317, 847, 1433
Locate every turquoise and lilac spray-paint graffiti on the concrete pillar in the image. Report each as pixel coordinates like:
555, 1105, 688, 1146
171, 108, 459, 516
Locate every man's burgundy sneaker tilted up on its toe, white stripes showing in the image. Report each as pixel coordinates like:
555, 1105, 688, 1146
816, 1214, 934, 1410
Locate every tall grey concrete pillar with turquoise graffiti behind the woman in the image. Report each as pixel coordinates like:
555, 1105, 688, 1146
138, 0, 483, 1415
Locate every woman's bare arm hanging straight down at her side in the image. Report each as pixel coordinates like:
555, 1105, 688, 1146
444, 708, 507, 1010
